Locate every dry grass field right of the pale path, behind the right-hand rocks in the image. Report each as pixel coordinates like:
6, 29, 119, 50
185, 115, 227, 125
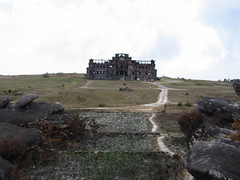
161, 79, 239, 110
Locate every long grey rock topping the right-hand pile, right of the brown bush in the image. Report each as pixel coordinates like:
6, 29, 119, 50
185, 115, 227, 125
197, 97, 240, 120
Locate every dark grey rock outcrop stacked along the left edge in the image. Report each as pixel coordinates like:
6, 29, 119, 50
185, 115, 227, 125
0, 94, 65, 180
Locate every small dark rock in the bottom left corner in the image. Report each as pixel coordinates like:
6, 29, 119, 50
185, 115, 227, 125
0, 157, 16, 180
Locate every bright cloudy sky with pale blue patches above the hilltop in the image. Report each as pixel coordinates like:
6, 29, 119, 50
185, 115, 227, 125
0, 0, 240, 80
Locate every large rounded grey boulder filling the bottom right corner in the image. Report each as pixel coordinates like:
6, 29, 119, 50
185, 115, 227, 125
187, 141, 240, 180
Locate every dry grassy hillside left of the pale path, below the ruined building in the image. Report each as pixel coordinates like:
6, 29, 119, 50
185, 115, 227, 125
0, 74, 159, 109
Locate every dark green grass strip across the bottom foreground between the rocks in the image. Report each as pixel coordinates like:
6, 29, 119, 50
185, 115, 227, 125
30, 152, 183, 180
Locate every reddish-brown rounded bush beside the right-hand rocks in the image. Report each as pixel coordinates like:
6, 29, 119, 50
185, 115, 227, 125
178, 109, 203, 141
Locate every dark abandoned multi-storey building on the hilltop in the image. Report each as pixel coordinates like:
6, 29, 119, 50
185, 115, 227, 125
87, 53, 157, 81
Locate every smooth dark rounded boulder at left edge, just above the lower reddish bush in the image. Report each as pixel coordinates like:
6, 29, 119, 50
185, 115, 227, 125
0, 122, 42, 147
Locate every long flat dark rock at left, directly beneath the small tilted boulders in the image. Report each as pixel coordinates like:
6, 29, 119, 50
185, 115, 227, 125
0, 102, 64, 125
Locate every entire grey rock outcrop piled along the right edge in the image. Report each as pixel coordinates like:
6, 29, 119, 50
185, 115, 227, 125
186, 86, 240, 180
